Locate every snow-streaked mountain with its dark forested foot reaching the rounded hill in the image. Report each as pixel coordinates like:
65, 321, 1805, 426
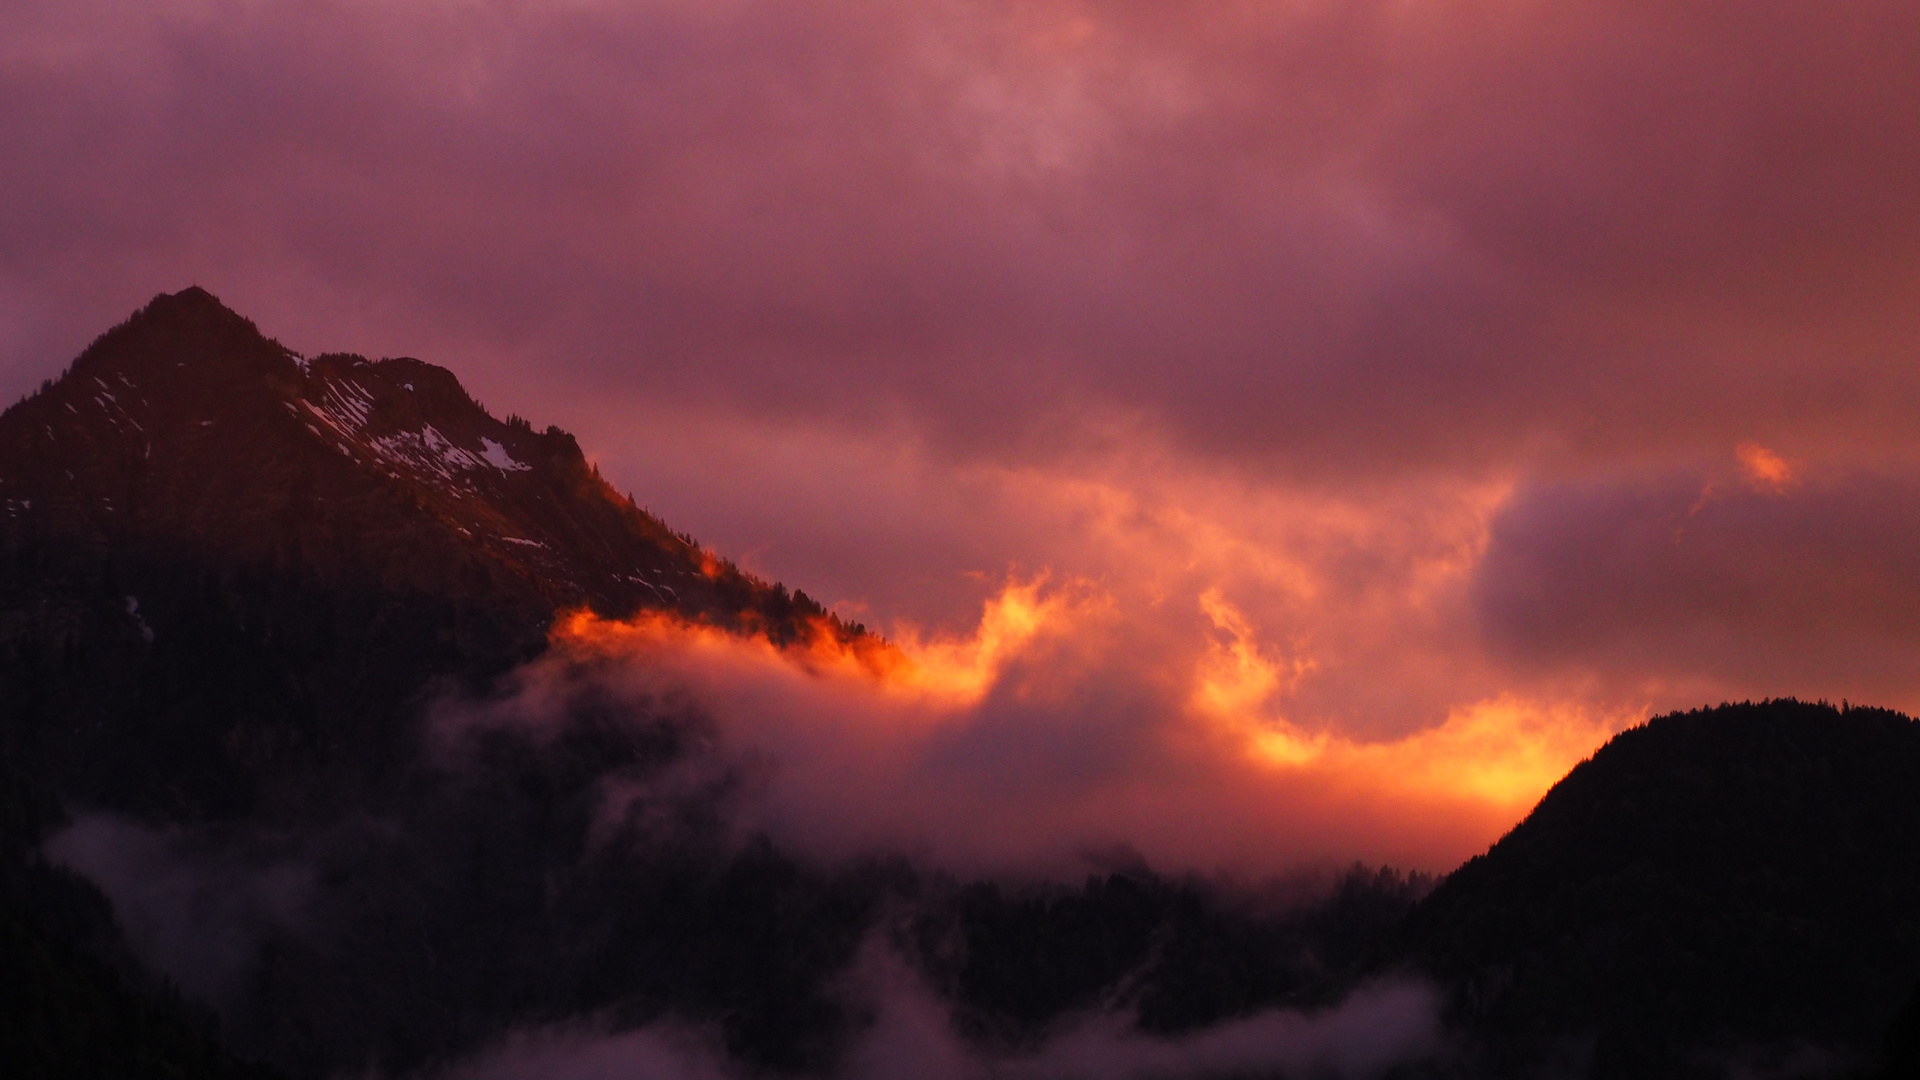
0, 288, 1425, 1076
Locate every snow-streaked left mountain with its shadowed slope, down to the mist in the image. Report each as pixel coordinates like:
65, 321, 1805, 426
0, 288, 856, 817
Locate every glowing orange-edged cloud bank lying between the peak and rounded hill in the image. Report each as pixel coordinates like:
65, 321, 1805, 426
532, 578, 1636, 872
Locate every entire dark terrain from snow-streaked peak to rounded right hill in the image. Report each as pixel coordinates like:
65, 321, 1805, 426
0, 290, 1920, 1078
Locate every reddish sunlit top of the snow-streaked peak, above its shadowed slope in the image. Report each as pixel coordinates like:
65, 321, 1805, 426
0, 286, 825, 619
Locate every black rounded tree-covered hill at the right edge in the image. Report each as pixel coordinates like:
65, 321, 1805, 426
1398, 700, 1920, 1080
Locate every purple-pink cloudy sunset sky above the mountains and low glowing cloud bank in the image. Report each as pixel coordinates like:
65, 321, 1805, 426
0, 0, 1920, 857
